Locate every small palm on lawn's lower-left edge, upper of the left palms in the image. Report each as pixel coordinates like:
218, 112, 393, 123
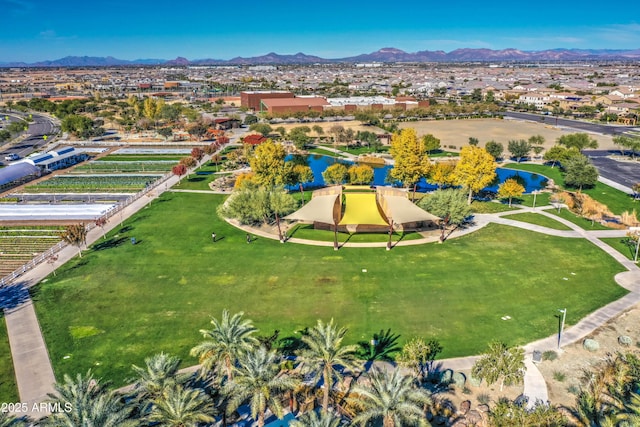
132, 353, 187, 413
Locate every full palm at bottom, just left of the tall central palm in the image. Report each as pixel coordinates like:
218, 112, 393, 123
226, 346, 297, 427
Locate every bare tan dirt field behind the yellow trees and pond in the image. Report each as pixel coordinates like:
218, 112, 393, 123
400, 119, 615, 150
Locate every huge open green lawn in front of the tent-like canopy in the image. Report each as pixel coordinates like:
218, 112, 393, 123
33, 193, 626, 385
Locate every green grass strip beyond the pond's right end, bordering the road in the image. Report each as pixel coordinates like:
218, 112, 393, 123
505, 163, 640, 215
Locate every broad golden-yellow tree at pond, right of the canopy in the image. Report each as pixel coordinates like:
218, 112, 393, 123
454, 145, 498, 204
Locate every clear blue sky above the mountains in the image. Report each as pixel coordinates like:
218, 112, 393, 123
0, 0, 640, 62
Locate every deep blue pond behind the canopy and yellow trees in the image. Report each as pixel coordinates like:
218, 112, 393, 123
287, 154, 547, 193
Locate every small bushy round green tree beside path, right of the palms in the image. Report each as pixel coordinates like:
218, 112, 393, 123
471, 341, 526, 391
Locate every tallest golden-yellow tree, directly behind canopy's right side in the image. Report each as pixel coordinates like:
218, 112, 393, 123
389, 128, 431, 200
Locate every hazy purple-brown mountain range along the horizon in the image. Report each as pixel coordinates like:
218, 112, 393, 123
0, 47, 640, 67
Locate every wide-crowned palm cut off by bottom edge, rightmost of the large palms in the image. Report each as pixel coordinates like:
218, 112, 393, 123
351, 369, 432, 427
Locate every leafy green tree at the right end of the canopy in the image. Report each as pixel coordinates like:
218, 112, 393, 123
419, 188, 472, 242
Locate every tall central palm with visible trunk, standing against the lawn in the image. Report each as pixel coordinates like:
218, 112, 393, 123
298, 319, 358, 412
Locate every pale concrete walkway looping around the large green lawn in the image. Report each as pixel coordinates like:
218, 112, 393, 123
5, 190, 640, 417
